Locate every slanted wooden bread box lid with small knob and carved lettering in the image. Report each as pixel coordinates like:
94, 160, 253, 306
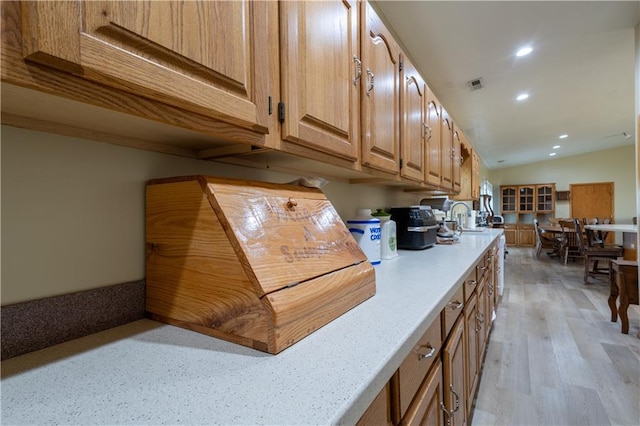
205, 177, 367, 293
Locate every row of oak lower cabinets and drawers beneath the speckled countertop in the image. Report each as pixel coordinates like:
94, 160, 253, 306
358, 243, 499, 426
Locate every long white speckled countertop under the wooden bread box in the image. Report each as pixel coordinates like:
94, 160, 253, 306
1, 229, 502, 425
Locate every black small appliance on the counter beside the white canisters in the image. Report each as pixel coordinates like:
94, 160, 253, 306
390, 206, 438, 250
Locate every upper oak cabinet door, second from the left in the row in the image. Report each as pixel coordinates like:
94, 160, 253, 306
280, 1, 360, 162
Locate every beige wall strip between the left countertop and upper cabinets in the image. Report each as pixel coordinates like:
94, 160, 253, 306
0, 126, 421, 305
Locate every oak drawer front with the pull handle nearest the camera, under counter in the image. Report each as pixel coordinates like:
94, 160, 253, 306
398, 317, 442, 417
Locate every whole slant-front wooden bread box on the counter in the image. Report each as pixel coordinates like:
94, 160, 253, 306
146, 176, 376, 354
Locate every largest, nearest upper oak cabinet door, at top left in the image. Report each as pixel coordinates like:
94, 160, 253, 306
22, 0, 272, 134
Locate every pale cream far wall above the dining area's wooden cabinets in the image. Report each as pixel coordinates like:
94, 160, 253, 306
489, 145, 636, 223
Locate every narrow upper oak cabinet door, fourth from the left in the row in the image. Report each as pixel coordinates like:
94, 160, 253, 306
400, 58, 427, 182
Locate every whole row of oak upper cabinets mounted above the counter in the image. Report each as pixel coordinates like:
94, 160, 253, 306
0, 0, 488, 193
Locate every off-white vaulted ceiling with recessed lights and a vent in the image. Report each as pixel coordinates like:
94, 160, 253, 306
373, 1, 640, 169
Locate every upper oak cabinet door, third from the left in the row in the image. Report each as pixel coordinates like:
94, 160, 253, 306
360, 2, 400, 174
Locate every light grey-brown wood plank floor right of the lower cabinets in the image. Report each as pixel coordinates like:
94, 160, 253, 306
471, 247, 640, 426
